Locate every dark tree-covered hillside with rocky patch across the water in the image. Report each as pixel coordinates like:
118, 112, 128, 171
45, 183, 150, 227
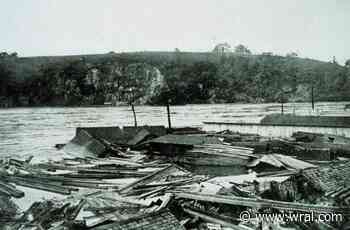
0, 50, 350, 106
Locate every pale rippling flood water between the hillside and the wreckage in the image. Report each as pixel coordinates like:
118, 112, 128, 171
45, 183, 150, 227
0, 102, 350, 162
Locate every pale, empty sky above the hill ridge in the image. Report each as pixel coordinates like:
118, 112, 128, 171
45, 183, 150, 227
0, 0, 350, 64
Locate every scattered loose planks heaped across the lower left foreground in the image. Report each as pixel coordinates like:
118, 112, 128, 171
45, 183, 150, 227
0, 153, 206, 229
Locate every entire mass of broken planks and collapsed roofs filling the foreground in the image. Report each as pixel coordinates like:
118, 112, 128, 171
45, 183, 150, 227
0, 126, 350, 230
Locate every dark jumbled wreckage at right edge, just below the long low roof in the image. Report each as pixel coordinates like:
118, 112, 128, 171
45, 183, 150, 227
210, 131, 350, 161
